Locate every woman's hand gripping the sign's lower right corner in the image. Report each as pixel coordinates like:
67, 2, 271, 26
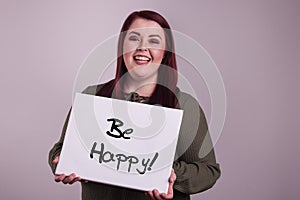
146, 169, 176, 200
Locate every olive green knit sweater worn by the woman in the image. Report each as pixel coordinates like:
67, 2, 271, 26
48, 82, 221, 200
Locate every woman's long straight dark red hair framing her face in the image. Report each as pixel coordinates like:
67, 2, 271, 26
98, 10, 178, 108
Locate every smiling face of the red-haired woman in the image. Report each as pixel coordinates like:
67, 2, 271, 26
123, 18, 166, 82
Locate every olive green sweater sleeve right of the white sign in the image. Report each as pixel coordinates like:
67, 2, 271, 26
173, 95, 221, 194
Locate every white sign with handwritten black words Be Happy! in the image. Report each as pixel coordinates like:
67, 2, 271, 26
55, 93, 183, 192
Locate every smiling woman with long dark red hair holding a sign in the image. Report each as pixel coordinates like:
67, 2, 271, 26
49, 11, 220, 199
